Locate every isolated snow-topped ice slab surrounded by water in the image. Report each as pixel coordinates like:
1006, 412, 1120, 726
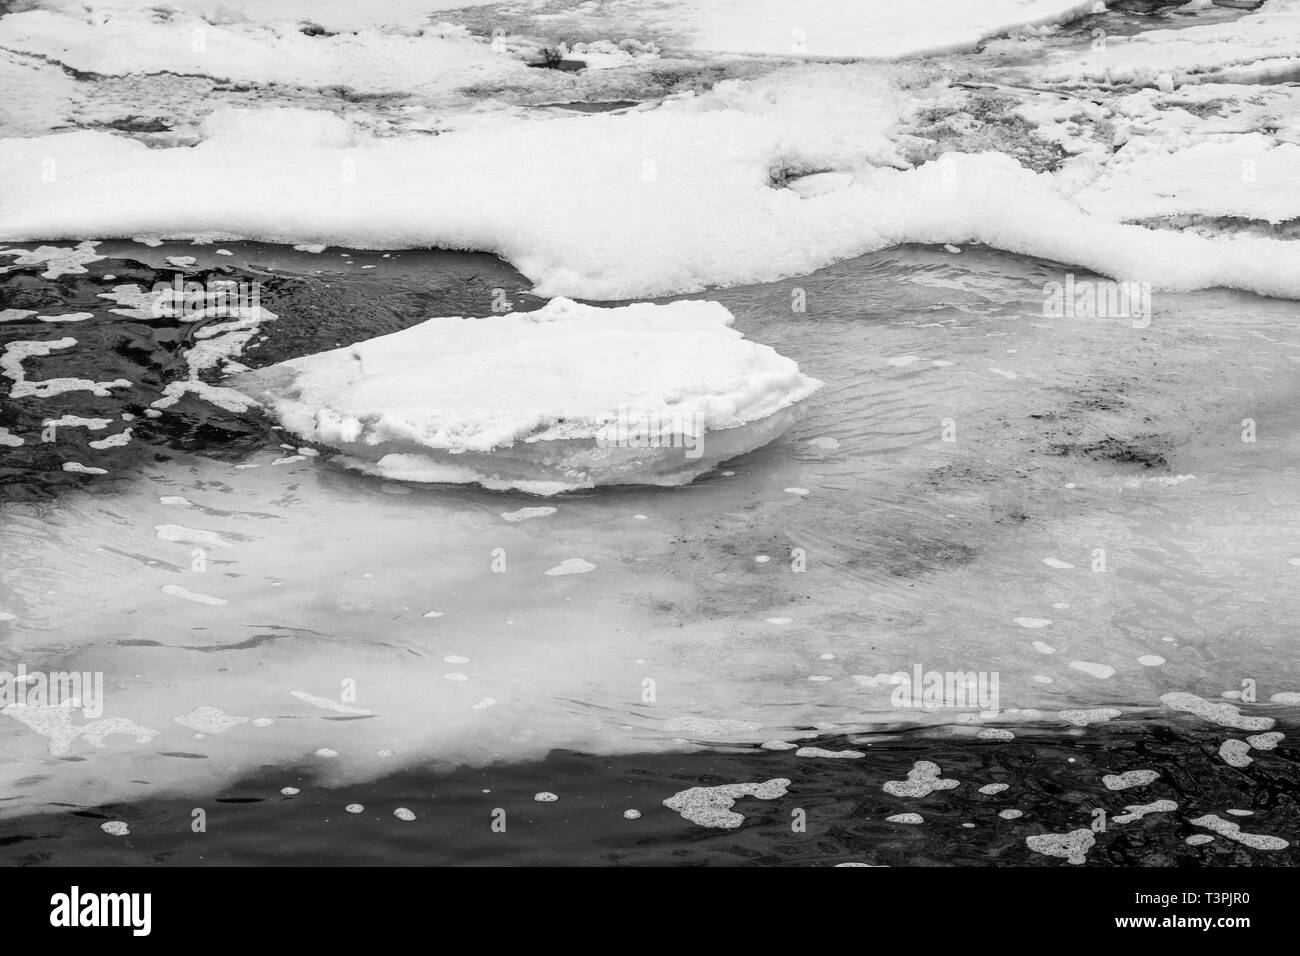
233, 298, 822, 494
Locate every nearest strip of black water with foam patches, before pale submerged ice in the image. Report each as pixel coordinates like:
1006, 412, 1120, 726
0, 721, 1300, 866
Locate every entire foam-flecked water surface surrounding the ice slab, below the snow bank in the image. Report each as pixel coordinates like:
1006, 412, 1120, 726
0, 243, 1300, 865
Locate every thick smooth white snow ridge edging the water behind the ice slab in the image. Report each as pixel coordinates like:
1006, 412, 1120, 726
10, 74, 1300, 299
